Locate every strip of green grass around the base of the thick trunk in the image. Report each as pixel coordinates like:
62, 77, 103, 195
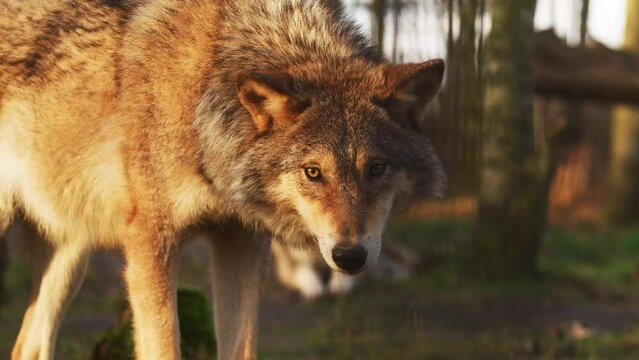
391, 219, 639, 298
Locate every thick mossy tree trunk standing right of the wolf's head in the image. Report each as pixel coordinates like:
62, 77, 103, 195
469, 0, 549, 279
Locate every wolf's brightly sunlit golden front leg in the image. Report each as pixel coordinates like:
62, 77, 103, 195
124, 235, 180, 360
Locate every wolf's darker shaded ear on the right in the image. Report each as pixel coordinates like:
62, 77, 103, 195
380, 59, 445, 128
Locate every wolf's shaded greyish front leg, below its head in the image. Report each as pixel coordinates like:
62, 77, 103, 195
211, 224, 270, 360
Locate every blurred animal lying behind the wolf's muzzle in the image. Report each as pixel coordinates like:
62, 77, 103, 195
271, 232, 420, 300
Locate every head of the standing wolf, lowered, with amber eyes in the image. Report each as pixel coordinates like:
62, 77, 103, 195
225, 60, 444, 273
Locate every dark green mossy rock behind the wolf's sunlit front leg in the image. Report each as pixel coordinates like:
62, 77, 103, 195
93, 288, 216, 360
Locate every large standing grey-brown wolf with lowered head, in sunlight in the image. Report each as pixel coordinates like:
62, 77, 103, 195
0, 0, 444, 359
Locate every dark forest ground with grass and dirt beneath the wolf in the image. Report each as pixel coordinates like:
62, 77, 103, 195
0, 220, 639, 360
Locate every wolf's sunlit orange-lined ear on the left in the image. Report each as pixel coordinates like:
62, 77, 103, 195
235, 73, 308, 133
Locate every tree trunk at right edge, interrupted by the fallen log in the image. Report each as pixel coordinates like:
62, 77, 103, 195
608, 0, 639, 225
